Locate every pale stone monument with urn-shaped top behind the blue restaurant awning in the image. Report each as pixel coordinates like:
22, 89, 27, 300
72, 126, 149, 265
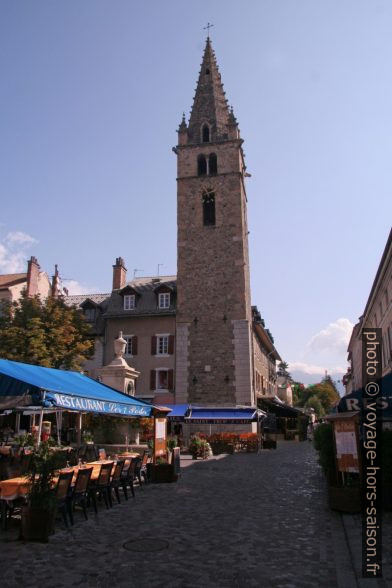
99, 331, 139, 396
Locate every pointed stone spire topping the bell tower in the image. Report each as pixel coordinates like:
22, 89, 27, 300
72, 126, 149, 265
188, 37, 230, 143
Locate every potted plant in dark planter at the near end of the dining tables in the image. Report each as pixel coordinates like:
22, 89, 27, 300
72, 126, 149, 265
21, 442, 60, 542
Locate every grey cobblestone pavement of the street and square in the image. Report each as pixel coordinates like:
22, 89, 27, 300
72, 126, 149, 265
0, 442, 392, 588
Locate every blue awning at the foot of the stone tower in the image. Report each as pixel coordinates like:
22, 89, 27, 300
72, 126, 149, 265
168, 404, 266, 424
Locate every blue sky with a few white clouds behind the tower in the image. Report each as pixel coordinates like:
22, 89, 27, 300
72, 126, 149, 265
0, 0, 392, 381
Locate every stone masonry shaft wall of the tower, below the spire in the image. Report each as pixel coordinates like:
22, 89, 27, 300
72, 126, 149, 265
176, 140, 252, 405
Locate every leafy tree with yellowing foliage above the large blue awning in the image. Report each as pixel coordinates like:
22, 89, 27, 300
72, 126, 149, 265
0, 292, 94, 370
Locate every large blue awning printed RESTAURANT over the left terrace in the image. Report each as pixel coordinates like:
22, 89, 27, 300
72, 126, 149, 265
0, 359, 154, 417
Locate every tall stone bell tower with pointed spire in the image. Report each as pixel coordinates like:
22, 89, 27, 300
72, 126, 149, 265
174, 38, 254, 406
